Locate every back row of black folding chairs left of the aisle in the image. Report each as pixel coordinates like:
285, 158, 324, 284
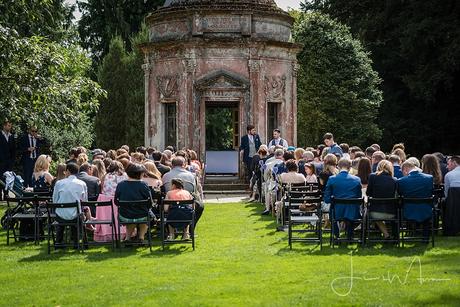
5, 192, 195, 253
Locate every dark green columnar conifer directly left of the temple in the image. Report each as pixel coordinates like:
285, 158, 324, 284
96, 27, 148, 149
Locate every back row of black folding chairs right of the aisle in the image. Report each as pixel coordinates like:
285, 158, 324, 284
278, 184, 439, 248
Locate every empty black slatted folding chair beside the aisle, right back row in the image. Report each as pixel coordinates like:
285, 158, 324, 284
287, 192, 323, 249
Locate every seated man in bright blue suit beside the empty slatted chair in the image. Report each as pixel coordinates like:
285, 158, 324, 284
324, 158, 362, 239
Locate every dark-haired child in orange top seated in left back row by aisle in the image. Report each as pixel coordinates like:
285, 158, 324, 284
165, 178, 193, 240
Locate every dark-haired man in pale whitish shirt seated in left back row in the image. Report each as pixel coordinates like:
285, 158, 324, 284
53, 162, 88, 247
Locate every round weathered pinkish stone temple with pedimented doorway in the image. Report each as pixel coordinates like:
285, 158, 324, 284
141, 0, 299, 157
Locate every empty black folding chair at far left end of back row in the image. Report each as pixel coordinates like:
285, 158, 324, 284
6, 192, 51, 245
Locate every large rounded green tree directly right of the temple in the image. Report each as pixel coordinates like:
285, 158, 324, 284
293, 12, 382, 146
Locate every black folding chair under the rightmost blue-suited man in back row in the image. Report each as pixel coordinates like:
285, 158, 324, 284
399, 196, 435, 247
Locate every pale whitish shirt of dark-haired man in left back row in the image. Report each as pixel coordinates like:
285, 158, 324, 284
53, 175, 88, 220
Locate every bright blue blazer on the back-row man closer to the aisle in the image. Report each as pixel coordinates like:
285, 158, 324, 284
324, 171, 362, 221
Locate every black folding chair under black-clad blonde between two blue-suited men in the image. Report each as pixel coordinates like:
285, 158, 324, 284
365, 197, 400, 246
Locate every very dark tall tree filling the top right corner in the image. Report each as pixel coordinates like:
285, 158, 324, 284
303, 0, 460, 154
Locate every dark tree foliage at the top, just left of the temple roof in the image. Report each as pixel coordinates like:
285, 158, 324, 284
77, 0, 164, 66
